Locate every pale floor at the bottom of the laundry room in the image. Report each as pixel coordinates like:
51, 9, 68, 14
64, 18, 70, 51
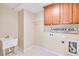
9, 46, 57, 56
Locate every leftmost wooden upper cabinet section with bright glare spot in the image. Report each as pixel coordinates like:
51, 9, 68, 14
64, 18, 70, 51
44, 4, 59, 25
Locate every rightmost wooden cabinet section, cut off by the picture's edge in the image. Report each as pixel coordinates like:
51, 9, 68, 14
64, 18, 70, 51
73, 3, 79, 24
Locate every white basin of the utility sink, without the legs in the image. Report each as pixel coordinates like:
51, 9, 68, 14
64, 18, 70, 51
0, 38, 17, 49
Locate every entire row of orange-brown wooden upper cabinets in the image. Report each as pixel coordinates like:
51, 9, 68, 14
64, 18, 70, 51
44, 3, 79, 25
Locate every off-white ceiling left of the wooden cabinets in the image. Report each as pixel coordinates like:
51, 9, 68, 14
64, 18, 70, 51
0, 3, 49, 13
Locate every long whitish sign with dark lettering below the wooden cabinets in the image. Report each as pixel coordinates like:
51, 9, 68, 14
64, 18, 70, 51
49, 26, 78, 33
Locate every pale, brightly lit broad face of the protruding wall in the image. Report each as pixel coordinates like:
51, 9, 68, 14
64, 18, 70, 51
24, 10, 35, 50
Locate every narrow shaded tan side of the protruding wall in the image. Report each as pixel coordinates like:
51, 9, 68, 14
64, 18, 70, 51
18, 10, 24, 49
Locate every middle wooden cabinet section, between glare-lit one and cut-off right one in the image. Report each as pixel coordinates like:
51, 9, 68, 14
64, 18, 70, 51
60, 3, 72, 24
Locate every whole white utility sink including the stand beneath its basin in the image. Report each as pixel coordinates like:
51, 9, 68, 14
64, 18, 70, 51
0, 37, 17, 55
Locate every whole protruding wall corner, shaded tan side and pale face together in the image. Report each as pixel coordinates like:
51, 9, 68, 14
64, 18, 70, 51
18, 10, 35, 51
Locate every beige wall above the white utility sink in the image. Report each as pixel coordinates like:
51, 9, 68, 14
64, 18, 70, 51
0, 6, 18, 38
